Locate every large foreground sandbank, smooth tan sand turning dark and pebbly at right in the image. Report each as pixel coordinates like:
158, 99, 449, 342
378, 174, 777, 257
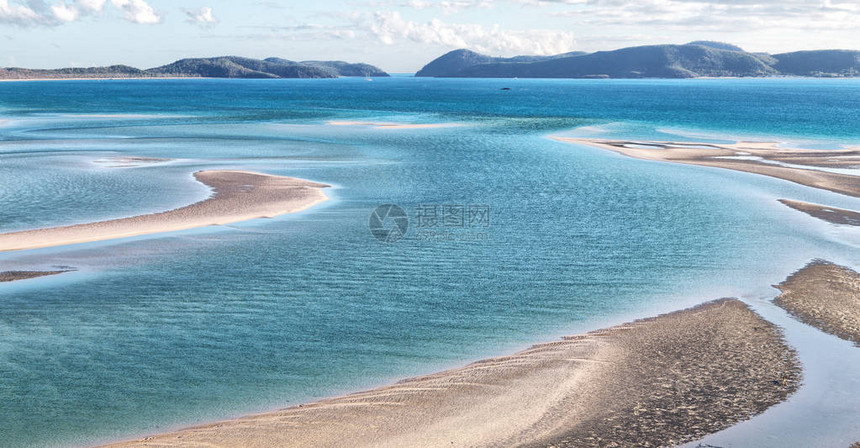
101, 299, 800, 447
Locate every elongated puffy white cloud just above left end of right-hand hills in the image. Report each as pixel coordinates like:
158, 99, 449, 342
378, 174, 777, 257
370, 11, 576, 55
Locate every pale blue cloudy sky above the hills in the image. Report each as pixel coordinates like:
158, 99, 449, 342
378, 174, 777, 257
0, 0, 860, 73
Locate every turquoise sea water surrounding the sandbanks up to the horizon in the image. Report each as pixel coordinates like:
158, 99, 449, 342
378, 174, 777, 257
0, 78, 860, 447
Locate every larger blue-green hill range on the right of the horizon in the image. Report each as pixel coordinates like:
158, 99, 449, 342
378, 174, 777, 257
415, 41, 860, 78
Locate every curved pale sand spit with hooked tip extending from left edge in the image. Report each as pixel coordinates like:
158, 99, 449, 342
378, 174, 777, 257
0, 170, 328, 252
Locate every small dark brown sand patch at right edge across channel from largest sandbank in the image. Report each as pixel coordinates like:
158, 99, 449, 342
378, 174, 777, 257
774, 261, 860, 347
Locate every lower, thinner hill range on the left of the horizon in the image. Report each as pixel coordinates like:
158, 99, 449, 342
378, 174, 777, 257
0, 56, 388, 79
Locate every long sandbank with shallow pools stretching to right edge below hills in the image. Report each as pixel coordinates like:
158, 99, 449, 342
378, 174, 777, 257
553, 137, 860, 197
